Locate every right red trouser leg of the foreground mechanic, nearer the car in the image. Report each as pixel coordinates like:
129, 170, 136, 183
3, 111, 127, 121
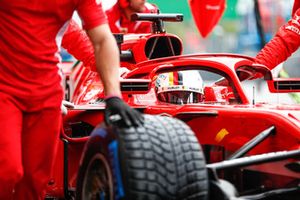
14, 96, 61, 200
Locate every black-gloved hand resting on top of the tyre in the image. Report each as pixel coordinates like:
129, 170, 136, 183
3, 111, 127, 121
104, 97, 144, 127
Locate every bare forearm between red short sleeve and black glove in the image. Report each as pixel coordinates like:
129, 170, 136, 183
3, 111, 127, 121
87, 24, 121, 96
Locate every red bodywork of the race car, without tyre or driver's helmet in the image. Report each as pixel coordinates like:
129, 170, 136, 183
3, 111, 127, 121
48, 15, 300, 197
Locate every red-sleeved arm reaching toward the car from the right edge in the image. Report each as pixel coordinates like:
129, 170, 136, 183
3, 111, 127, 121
255, 0, 300, 69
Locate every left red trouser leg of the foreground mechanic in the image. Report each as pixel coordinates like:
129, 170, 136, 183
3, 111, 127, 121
0, 92, 23, 199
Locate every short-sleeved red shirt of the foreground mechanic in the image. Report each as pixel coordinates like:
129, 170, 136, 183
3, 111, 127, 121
0, 0, 107, 98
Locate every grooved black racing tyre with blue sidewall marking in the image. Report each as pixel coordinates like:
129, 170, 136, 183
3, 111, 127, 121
76, 115, 208, 200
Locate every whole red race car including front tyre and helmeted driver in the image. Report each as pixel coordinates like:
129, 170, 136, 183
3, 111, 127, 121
48, 14, 300, 200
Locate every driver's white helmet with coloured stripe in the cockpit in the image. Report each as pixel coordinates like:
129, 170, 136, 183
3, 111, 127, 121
155, 70, 204, 104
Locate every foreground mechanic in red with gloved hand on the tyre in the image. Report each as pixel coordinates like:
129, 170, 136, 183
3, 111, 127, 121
0, 0, 143, 200
